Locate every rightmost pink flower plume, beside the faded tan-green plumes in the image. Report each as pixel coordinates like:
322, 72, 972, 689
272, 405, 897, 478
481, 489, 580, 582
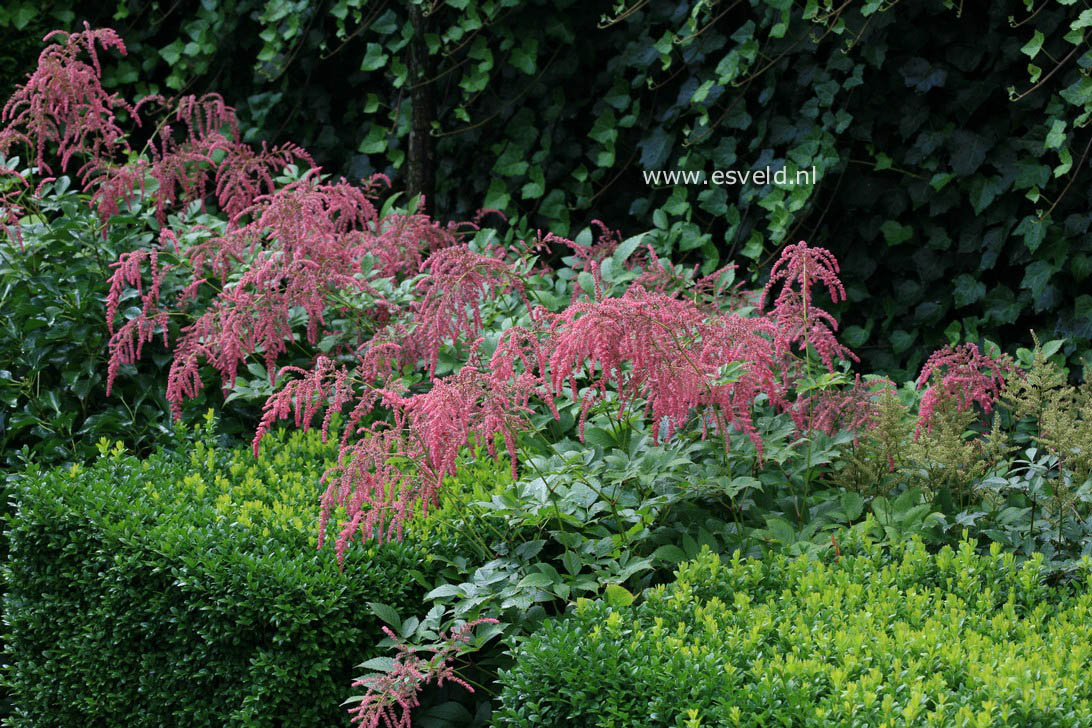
914, 344, 1014, 439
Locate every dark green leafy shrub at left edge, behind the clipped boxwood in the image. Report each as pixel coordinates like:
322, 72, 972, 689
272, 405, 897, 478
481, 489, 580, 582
0, 177, 258, 469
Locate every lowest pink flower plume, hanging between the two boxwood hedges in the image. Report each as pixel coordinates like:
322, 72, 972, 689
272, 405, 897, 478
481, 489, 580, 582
348, 618, 499, 728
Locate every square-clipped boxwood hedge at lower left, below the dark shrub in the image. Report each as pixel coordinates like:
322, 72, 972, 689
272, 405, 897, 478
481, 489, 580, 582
5, 414, 460, 728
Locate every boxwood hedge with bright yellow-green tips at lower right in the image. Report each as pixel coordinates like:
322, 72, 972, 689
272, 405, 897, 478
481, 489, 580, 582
494, 534, 1092, 728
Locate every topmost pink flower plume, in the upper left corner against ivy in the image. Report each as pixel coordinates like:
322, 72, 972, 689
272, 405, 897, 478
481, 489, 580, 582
0, 23, 131, 174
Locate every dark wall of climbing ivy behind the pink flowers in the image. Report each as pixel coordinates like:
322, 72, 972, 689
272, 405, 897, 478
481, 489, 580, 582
0, 0, 1092, 375
